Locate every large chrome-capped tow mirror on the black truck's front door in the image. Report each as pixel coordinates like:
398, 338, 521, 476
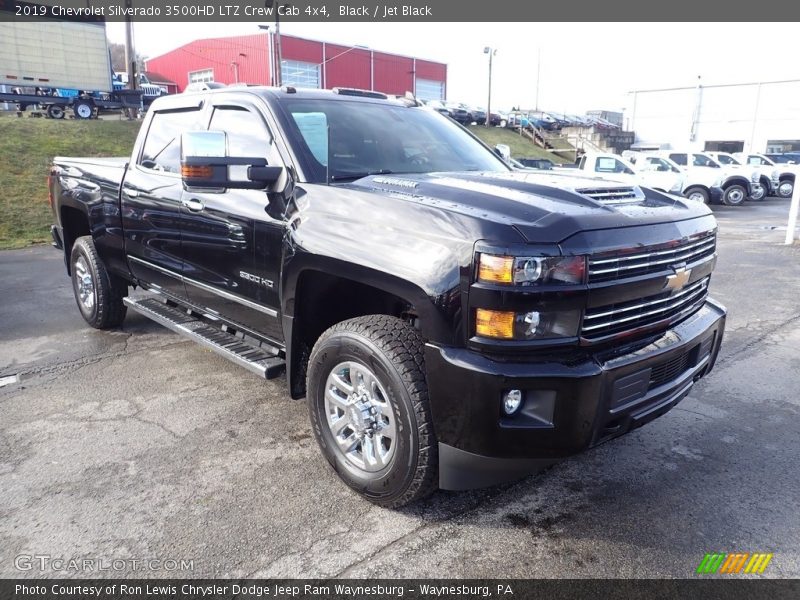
181, 131, 283, 191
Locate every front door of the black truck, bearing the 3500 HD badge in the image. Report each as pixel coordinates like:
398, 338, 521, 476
181, 100, 284, 342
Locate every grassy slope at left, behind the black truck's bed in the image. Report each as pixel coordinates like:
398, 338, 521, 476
0, 115, 140, 250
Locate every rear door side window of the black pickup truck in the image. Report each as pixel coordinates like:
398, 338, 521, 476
139, 109, 205, 173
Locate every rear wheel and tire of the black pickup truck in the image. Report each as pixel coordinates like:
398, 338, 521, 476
70, 235, 128, 329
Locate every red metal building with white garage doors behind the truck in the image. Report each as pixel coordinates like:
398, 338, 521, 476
147, 31, 447, 100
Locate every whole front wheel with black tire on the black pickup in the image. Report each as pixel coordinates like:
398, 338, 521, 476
307, 315, 439, 508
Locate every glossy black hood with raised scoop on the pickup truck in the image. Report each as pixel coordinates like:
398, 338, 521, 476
347, 171, 710, 243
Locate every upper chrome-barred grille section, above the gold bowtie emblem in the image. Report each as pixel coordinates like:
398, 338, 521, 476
589, 232, 717, 283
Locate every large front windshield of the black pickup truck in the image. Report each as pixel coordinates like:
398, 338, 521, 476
281, 98, 509, 183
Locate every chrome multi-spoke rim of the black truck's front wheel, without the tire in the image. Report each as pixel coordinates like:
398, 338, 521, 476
325, 361, 397, 473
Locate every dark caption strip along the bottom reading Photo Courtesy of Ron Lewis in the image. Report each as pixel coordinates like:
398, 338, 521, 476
0, 578, 800, 600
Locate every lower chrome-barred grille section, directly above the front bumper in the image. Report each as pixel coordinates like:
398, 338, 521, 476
581, 276, 711, 341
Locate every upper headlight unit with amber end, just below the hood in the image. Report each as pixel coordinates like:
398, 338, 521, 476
478, 254, 586, 285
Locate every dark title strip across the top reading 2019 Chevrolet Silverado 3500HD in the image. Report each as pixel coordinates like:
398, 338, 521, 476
0, 0, 800, 22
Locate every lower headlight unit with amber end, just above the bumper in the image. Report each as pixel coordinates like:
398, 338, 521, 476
475, 308, 581, 340
